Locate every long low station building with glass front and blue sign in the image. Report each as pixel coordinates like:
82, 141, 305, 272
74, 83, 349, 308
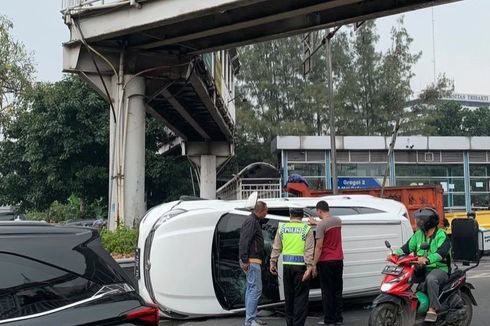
271, 136, 490, 211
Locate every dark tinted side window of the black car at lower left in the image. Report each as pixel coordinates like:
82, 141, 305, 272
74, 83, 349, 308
0, 253, 101, 320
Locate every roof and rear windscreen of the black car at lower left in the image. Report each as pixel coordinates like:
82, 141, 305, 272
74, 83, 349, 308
0, 221, 132, 284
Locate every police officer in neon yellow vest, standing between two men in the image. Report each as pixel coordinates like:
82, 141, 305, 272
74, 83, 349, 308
270, 208, 315, 326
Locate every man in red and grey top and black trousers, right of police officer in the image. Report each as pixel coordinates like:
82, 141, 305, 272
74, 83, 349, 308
310, 200, 344, 325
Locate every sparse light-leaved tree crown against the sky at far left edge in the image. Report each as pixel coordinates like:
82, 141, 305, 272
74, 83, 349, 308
0, 15, 34, 112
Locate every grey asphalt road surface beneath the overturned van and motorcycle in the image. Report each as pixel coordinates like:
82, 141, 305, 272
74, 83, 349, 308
160, 257, 490, 326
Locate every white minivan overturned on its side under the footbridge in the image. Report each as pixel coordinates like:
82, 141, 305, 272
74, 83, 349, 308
136, 195, 412, 318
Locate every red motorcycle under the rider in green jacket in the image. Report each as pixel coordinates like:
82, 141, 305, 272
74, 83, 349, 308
369, 241, 478, 326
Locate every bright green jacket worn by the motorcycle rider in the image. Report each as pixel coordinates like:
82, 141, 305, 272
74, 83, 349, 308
394, 228, 451, 273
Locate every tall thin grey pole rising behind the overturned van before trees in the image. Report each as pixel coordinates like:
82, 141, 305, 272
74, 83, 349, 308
326, 28, 338, 195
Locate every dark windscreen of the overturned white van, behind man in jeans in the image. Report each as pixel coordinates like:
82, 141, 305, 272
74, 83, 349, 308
212, 213, 279, 310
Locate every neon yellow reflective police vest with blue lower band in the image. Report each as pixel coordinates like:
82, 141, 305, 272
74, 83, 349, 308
279, 221, 311, 266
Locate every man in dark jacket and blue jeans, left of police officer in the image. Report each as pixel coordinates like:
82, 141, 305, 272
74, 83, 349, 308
239, 201, 267, 326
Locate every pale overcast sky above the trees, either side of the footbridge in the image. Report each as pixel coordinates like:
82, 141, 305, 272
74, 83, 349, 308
0, 0, 490, 95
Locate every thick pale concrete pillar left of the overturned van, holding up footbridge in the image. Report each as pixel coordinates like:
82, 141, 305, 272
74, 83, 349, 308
109, 75, 146, 229
